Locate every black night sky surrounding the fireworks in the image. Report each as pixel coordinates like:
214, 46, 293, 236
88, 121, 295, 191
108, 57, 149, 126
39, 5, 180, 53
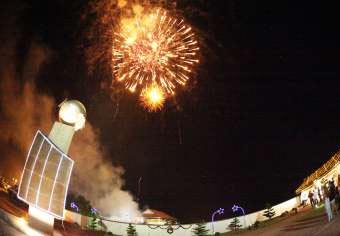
1, 0, 340, 222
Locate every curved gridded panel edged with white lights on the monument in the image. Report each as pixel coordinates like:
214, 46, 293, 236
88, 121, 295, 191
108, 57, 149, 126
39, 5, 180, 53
18, 131, 74, 219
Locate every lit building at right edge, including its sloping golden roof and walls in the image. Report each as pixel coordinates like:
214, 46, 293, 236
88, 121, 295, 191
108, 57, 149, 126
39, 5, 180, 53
295, 150, 340, 202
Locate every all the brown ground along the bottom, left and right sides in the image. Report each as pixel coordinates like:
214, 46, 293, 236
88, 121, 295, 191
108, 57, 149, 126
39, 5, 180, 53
0, 192, 340, 236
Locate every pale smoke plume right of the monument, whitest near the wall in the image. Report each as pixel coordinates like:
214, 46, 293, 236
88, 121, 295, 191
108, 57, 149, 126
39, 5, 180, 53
70, 123, 140, 220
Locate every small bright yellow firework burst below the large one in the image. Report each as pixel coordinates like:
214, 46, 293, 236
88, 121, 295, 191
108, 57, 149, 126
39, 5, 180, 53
140, 84, 165, 111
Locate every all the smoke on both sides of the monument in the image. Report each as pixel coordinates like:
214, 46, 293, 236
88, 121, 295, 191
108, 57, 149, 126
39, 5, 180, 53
0, 18, 140, 220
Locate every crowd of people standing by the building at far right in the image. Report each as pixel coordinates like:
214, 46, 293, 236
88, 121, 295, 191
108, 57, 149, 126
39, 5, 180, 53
308, 180, 340, 221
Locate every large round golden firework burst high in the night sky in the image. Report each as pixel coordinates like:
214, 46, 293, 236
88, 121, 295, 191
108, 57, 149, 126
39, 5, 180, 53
112, 8, 199, 96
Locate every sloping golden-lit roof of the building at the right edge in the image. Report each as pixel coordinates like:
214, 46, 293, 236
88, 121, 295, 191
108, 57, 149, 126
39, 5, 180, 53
295, 150, 340, 194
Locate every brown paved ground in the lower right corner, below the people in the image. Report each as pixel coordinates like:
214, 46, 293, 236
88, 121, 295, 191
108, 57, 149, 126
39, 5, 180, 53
228, 207, 340, 236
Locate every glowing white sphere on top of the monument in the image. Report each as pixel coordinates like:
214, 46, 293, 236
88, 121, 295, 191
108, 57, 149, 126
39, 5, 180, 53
59, 100, 86, 130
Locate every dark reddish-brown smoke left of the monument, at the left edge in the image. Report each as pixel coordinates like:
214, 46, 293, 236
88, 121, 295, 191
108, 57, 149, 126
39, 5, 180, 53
0, 43, 54, 177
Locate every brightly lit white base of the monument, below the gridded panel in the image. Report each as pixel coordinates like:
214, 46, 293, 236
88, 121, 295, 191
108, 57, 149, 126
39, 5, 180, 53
28, 206, 54, 235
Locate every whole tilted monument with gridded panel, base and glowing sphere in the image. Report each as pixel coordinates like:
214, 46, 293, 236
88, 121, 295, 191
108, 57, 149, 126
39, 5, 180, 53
18, 100, 86, 235
